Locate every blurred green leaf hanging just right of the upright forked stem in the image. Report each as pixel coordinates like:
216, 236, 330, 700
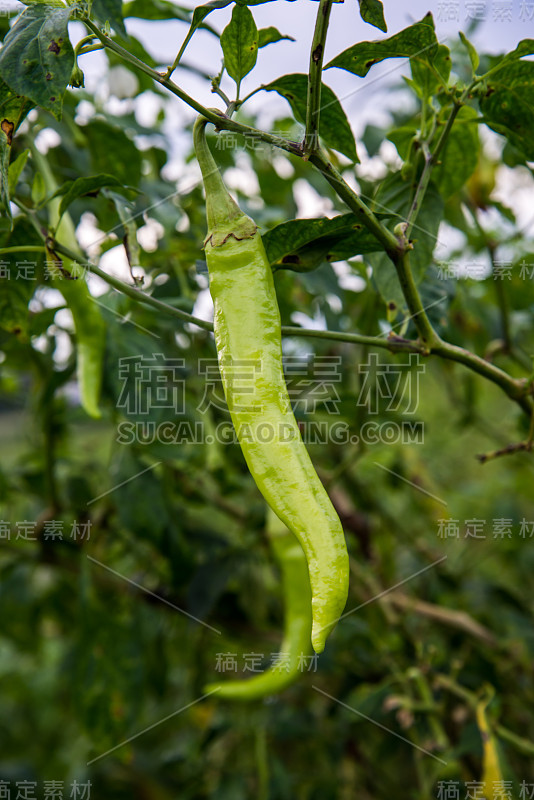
433, 106, 480, 199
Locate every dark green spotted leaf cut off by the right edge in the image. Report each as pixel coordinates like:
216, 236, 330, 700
479, 61, 534, 161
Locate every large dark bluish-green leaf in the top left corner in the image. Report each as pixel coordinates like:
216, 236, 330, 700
0, 5, 74, 119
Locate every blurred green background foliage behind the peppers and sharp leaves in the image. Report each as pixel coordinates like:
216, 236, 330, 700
0, 3, 534, 800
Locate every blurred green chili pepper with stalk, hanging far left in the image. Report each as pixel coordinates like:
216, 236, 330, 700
32, 147, 106, 418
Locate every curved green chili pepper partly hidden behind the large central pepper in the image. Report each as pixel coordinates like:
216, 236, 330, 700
205, 509, 312, 700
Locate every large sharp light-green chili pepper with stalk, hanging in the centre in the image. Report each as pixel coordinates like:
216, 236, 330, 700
194, 118, 349, 653
